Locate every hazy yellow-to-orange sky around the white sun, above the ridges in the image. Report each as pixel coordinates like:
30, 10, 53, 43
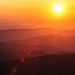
0, 0, 75, 29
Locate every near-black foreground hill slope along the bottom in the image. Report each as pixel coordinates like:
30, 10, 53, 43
0, 54, 75, 75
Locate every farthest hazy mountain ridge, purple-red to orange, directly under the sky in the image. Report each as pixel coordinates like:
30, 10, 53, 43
0, 28, 75, 42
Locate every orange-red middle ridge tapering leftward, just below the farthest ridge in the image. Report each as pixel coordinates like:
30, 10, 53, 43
16, 34, 75, 51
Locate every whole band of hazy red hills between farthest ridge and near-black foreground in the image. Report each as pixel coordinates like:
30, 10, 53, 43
0, 34, 75, 60
